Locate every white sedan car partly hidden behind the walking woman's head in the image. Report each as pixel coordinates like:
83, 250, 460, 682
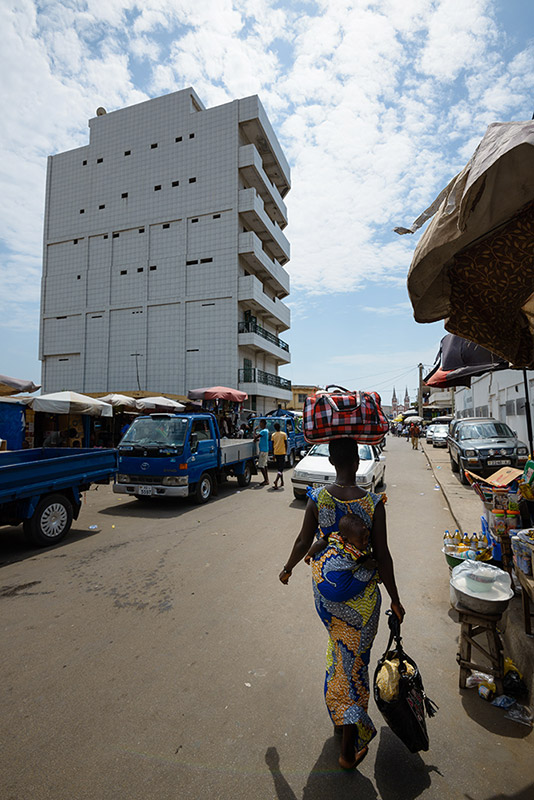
291, 444, 386, 499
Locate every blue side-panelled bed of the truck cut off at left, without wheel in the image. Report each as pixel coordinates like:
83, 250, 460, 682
0, 447, 117, 503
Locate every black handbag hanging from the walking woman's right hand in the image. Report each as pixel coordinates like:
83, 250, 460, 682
373, 611, 438, 753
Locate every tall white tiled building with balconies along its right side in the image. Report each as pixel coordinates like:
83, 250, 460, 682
40, 89, 292, 411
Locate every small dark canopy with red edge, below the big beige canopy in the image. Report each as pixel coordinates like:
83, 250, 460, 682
423, 333, 509, 389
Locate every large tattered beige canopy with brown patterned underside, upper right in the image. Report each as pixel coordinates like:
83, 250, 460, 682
395, 121, 534, 368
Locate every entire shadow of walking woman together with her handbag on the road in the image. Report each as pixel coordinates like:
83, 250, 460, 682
265, 727, 438, 800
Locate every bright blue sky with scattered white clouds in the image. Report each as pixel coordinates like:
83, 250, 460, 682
0, 0, 534, 403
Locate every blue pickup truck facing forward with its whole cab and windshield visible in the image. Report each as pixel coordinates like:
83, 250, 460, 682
113, 412, 256, 503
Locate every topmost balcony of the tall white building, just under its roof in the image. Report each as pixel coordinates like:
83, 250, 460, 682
238, 95, 291, 197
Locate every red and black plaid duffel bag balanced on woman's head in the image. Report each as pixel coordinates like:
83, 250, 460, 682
304, 386, 389, 444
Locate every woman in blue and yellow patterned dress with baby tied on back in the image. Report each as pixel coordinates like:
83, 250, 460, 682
279, 438, 405, 769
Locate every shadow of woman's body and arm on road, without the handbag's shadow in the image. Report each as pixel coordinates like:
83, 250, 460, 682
265, 736, 378, 800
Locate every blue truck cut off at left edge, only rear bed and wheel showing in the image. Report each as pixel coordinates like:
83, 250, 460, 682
0, 447, 117, 546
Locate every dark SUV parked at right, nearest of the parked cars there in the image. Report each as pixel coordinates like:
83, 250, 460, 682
447, 417, 528, 484
